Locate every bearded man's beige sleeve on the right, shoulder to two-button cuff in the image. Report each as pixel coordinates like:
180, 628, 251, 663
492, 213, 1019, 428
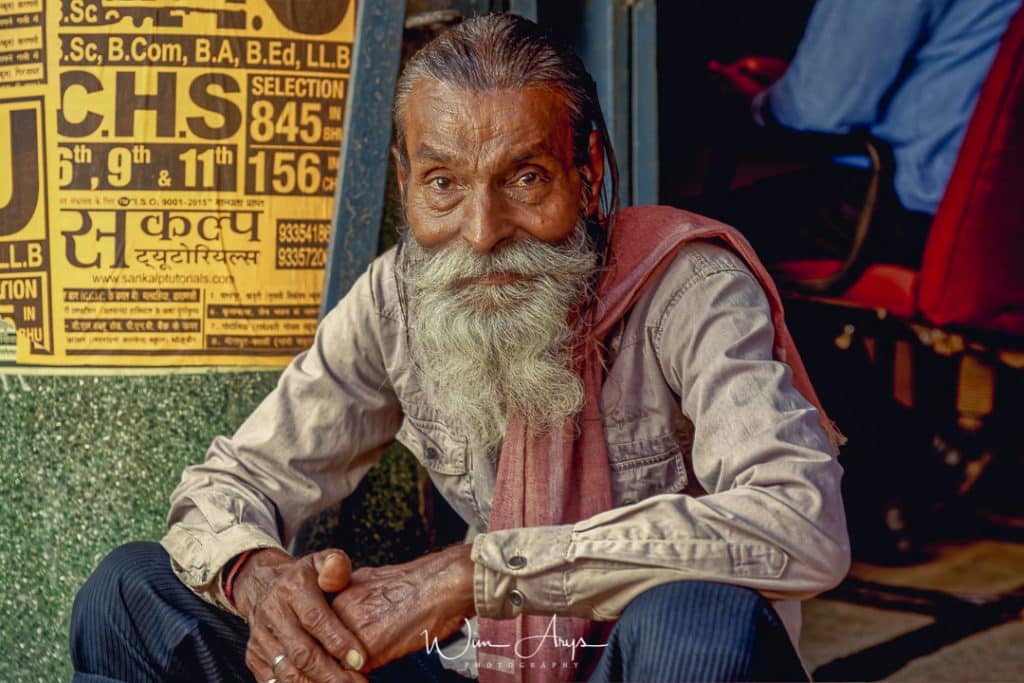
472, 246, 849, 621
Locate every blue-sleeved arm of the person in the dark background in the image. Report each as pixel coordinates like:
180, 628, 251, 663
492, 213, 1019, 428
761, 0, 948, 133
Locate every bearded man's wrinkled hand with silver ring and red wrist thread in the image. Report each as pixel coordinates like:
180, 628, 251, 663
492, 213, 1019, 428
233, 548, 367, 683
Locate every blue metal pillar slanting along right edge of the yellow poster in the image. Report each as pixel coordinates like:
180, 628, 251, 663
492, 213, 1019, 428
321, 0, 406, 317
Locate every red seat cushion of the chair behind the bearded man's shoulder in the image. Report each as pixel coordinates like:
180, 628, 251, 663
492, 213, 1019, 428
773, 259, 918, 319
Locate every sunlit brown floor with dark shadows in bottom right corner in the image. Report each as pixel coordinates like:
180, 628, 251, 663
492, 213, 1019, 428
801, 540, 1024, 681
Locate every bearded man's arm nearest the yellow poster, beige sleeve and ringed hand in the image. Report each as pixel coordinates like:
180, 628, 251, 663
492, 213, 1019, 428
163, 255, 401, 681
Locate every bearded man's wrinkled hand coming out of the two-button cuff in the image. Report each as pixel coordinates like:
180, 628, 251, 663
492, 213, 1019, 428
332, 545, 475, 671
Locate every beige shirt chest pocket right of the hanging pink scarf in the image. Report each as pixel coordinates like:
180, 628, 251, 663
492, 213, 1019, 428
608, 435, 686, 506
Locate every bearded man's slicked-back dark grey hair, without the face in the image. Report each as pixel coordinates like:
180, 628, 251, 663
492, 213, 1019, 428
393, 14, 618, 227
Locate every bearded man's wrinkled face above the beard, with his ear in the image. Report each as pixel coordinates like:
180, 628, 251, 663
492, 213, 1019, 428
398, 78, 602, 260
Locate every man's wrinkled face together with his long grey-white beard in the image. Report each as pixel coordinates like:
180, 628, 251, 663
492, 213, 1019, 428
397, 81, 602, 451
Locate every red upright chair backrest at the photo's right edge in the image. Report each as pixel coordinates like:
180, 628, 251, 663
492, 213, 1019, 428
919, 7, 1024, 335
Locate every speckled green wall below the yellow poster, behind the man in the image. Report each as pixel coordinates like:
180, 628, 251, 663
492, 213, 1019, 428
0, 370, 426, 683
